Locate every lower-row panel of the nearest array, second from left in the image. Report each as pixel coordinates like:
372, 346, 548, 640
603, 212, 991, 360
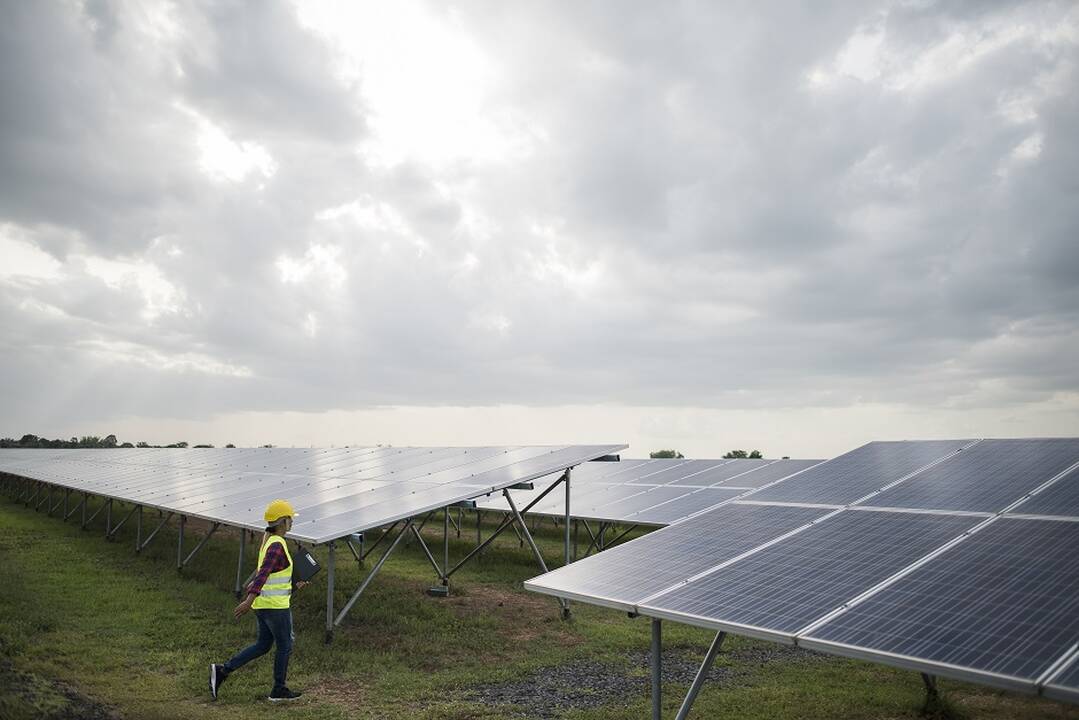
641, 511, 981, 640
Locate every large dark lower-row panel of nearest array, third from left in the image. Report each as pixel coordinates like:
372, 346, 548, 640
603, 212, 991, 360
806, 517, 1079, 689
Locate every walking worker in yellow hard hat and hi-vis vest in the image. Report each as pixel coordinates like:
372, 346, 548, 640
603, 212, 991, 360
209, 500, 306, 703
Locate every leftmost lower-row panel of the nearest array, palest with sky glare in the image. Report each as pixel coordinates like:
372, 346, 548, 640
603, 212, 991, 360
524, 505, 828, 610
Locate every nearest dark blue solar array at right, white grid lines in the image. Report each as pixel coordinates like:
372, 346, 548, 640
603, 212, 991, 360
525, 438, 1079, 702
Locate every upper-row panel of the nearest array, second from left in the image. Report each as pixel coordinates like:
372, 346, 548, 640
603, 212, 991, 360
871, 438, 1079, 513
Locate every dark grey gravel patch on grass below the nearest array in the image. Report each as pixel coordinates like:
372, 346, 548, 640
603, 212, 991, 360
465, 644, 825, 719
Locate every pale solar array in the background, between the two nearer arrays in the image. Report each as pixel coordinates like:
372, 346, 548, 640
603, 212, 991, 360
478, 459, 822, 526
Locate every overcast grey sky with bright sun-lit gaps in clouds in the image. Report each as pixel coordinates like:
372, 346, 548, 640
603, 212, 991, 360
0, 0, 1079, 457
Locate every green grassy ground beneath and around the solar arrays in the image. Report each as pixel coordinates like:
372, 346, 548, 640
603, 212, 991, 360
0, 495, 1079, 720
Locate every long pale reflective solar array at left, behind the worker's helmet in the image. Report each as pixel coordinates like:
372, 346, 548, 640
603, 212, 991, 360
0, 445, 625, 543
